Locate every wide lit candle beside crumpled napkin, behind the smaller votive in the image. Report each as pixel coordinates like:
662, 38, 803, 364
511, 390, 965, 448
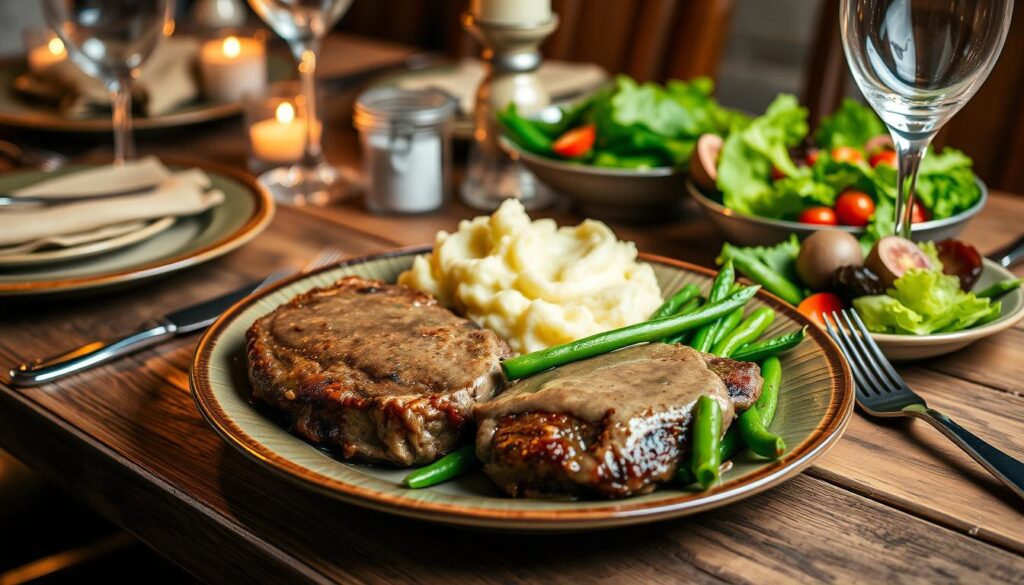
199, 37, 266, 102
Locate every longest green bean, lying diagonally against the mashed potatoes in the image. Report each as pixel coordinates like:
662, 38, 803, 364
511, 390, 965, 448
502, 286, 761, 380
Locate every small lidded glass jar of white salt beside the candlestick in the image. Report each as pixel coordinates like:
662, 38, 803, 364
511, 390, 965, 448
354, 87, 457, 213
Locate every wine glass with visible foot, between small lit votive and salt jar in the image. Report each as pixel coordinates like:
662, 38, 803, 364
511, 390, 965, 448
249, 0, 352, 205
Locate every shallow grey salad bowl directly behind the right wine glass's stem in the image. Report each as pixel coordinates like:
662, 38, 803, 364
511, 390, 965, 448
685, 178, 988, 246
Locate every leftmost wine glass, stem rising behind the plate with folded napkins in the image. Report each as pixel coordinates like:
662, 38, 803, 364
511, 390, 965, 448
43, 0, 174, 164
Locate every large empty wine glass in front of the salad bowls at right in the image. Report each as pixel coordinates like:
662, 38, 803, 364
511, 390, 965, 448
840, 0, 1014, 238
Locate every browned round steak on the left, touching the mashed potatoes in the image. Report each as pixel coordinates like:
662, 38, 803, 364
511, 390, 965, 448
246, 277, 510, 465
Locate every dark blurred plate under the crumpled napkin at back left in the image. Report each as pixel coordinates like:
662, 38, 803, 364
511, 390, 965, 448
0, 55, 292, 132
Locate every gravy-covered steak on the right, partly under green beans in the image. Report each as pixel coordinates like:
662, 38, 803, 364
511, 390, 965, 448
475, 343, 763, 498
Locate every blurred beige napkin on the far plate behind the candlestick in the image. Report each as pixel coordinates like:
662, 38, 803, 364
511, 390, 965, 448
398, 58, 608, 114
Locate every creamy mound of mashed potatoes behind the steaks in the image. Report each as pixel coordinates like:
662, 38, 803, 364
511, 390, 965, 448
398, 200, 662, 353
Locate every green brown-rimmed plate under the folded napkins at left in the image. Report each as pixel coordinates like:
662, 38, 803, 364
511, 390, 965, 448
0, 159, 274, 297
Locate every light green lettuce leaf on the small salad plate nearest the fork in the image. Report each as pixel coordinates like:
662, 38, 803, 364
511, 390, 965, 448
853, 269, 1001, 335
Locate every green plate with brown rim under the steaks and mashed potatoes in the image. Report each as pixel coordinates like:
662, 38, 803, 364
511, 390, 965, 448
189, 248, 853, 532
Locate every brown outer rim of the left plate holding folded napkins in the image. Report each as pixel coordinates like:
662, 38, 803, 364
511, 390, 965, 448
0, 157, 274, 297
